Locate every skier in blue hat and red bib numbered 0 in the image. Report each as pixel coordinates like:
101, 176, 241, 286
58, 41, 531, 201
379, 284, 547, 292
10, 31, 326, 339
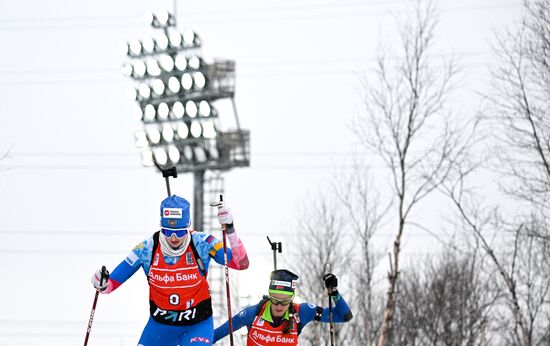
91, 195, 248, 346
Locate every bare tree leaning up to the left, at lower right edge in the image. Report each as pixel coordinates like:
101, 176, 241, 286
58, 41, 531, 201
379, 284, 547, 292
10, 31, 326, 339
441, 169, 550, 346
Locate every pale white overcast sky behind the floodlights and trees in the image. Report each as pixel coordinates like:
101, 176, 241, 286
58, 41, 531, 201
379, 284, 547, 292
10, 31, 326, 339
0, 0, 521, 346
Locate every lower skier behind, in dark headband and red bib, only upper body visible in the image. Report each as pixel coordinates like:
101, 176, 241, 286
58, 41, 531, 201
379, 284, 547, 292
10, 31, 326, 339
214, 269, 353, 346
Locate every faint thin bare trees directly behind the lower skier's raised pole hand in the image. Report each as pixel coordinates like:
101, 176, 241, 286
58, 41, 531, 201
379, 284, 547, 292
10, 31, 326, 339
295, 161, 387, 345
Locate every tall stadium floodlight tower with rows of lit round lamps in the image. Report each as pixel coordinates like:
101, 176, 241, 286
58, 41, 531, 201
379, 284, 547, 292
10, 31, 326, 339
120, 10, 250, 230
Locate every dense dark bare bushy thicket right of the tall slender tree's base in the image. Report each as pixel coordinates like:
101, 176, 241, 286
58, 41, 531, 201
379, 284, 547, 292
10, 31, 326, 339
392, 249, 497, 345
